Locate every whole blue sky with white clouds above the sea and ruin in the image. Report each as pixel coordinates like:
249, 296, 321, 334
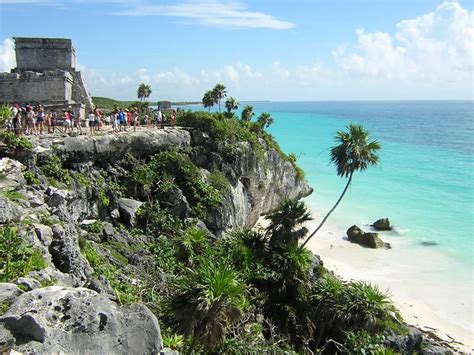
0, 0, 474, 100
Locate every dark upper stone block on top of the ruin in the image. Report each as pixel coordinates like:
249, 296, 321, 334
14, 37, 76, 71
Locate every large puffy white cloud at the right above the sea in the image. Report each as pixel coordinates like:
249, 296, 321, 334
333, 1, 474, 82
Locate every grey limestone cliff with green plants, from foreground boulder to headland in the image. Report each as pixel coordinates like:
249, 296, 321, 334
0, 130, 312, 354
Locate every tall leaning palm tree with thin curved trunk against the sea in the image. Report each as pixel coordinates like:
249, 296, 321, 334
301, 123, 381, 248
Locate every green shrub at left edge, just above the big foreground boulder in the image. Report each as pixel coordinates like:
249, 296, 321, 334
0, 226, 47, 282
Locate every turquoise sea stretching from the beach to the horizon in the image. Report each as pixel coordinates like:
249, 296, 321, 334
183, 101, 474, 268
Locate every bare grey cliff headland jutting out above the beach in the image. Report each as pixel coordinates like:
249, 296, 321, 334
193, 140, 313, 236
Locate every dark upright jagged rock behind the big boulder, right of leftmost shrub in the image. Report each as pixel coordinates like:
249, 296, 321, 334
49, 224, 92, 280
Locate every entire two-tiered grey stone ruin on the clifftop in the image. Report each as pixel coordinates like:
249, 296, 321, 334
0, 37, 92, 117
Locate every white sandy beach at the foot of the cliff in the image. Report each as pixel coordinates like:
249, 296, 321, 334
300, 217, 474, 353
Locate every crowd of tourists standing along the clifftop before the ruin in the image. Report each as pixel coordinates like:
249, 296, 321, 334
7, 103, 176, 136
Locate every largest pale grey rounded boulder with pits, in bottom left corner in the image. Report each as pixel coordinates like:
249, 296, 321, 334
0, 286, 163, 354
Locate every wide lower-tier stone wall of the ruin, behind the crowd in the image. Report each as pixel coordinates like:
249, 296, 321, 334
0, 70, 72, 104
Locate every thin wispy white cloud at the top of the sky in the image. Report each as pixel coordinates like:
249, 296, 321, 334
116, 0, 295, 30
